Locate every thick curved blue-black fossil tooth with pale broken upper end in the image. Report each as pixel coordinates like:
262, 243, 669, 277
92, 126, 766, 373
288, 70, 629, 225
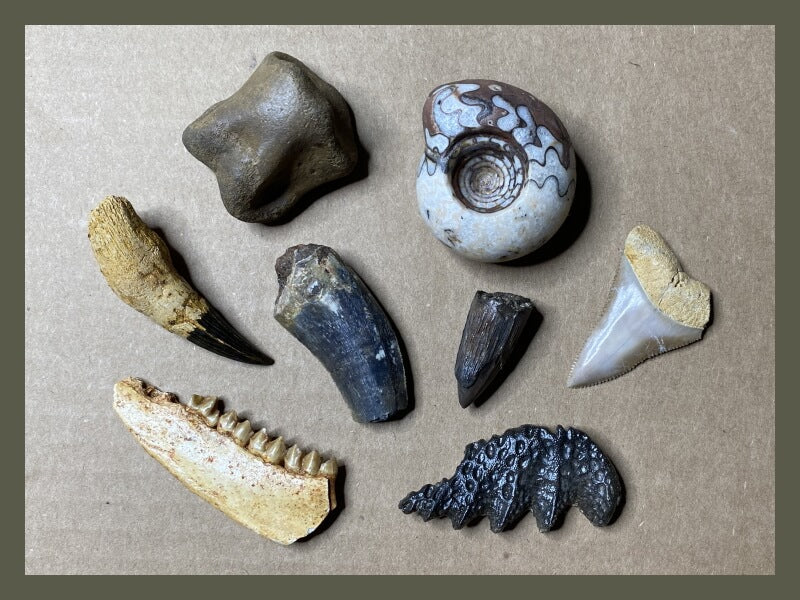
275, 244, 408, 423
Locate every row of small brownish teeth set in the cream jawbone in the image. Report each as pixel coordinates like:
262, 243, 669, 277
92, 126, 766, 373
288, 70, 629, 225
189, 394, 339, 479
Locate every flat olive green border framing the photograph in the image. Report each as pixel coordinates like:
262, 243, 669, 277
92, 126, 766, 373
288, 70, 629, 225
15, 0, 784, 600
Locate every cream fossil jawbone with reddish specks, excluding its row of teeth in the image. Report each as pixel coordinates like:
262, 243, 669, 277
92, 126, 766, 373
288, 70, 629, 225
114, 378, 336, 544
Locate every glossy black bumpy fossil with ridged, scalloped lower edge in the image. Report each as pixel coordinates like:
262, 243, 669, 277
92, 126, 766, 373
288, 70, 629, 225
399, 425, 623, 533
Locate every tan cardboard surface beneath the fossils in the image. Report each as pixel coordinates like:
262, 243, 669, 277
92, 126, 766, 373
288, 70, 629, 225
25, 26, 775, 573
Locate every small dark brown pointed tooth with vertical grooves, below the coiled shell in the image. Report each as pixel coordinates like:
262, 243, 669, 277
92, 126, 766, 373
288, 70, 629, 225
455, 291, 534, 408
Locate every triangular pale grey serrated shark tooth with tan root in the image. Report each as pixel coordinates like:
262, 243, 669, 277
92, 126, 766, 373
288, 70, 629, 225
567, 225, 711, 387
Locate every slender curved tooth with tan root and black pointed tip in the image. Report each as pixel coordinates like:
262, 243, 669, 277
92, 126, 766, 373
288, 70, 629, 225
89, 196, 273, 365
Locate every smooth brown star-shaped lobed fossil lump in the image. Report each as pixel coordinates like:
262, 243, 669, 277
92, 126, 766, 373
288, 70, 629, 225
183, 52, 358, 223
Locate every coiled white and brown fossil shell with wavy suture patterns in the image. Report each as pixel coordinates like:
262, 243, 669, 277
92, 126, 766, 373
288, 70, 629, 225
417, 79, 575, 262
